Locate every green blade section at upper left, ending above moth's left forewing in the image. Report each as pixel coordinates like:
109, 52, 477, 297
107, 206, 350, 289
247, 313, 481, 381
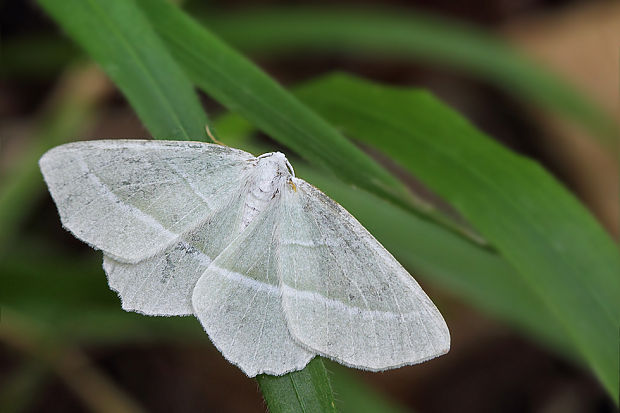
39, 0, 207, 140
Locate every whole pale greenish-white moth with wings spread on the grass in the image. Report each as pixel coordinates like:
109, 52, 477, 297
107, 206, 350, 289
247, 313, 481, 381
39, 140, 450, 377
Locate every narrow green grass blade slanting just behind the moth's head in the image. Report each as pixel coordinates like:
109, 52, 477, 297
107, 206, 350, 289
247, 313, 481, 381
138, 0, 416, 212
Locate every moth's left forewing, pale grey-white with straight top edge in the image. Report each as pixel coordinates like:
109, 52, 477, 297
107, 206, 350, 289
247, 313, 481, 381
39, 140, 254, 263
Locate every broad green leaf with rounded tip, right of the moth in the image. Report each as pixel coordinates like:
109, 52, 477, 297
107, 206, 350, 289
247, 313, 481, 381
299, 75, 620, 401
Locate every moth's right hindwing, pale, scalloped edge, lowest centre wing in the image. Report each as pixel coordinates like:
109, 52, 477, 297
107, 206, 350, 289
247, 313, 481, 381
192, 198, 314, 377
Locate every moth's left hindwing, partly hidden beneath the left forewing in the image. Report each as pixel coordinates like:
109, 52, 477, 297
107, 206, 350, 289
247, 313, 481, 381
103, 185, 256, 315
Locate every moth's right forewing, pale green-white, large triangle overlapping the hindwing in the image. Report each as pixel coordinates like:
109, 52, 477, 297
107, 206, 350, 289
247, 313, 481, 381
278, 179, 450, 371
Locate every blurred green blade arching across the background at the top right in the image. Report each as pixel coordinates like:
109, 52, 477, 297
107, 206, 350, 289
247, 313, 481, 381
203, 6, 618, 144
